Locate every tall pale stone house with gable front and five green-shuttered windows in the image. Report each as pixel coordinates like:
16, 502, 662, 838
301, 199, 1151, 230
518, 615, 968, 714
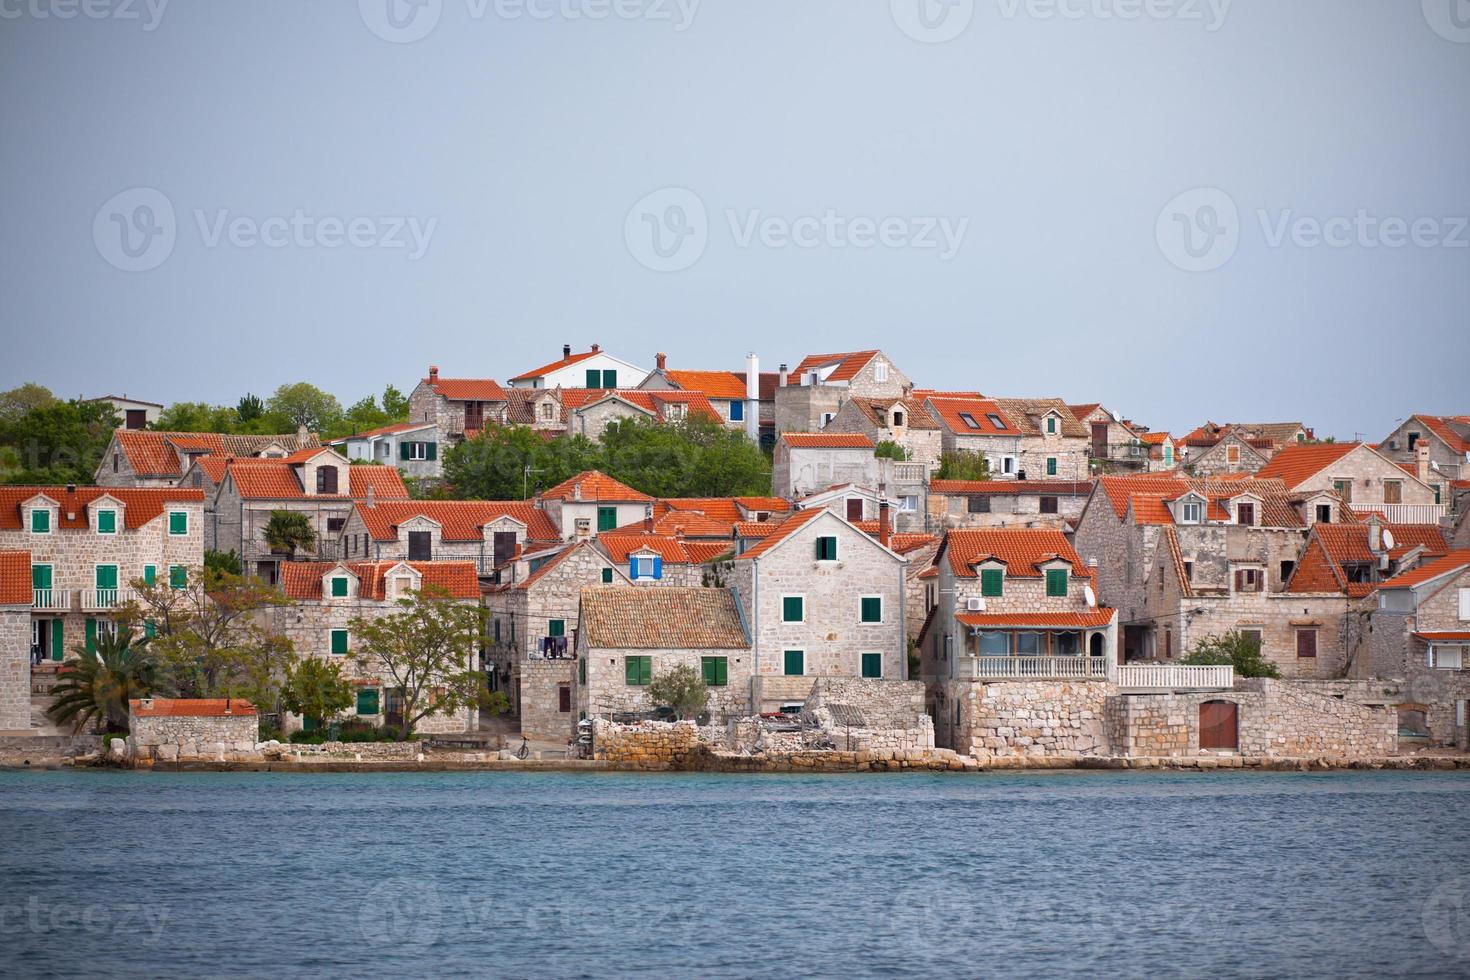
723, 508, 908, 711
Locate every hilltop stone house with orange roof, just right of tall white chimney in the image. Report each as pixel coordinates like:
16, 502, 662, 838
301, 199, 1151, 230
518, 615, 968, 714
775, 351, 913, 436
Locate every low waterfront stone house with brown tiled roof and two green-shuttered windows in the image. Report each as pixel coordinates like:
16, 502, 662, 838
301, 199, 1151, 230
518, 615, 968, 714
567, 585, 756, 735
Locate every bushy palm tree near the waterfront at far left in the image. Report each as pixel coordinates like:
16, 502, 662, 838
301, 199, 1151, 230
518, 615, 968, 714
46, 624, 154, 732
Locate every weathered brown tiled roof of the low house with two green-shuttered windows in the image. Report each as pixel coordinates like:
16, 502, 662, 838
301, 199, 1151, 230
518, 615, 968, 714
579, 586, 750, 649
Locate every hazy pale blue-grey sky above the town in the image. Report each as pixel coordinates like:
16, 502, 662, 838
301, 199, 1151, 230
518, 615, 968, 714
0, 0, 1470, 439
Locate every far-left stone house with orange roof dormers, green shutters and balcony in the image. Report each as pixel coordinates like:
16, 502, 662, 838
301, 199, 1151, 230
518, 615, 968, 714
0, 486, 204, 663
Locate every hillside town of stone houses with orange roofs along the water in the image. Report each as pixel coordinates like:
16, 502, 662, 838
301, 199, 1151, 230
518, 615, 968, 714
0, 344, 1470, 768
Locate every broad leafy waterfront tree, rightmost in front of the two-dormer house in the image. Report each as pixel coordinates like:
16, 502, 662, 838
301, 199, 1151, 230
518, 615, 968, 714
347, 589, 485, 741
